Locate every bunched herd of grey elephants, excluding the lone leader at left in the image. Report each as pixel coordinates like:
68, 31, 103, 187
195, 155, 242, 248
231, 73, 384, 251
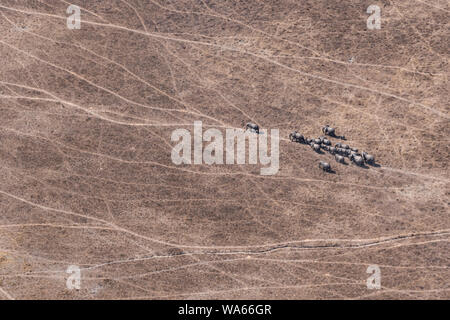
289, 125, 375, 172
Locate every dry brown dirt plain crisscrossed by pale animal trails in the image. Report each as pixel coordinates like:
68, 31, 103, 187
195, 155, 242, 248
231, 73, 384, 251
0, 0, 450, 299
